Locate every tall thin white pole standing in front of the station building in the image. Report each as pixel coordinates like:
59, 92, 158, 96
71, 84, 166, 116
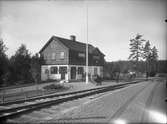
86, 3, 89, 84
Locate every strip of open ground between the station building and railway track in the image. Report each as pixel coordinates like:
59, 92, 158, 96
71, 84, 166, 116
0, 81, 126, 103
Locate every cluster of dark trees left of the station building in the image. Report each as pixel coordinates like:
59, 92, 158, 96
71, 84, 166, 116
0, 39, 43, 87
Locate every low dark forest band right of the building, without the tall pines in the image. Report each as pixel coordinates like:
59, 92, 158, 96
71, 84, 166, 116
104, 60, 167, 80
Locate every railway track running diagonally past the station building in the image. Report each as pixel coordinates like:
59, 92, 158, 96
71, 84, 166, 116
0, 80, 143, 122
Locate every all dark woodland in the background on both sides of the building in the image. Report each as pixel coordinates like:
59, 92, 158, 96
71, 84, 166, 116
0, 34, 167, 87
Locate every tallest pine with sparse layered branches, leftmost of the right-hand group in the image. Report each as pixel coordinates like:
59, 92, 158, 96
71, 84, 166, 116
129, 34, 145, 71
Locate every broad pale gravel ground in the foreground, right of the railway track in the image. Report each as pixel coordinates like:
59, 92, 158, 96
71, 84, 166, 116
7, 80, 167, 124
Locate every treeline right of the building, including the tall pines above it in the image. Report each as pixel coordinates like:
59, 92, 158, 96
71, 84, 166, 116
104, 34, 167, 79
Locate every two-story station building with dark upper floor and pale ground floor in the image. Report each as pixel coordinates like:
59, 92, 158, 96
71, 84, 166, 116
39, 35, 104, 81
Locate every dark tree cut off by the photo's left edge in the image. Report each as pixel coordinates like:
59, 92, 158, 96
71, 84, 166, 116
0, 39, 8, 86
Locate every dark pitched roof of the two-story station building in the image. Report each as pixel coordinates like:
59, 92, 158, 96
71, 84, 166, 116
39, 36, 104, 56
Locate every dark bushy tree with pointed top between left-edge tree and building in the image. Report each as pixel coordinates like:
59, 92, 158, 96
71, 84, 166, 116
10, 44, 32, 82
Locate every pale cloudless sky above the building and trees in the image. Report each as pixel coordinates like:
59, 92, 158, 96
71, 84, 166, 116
0, 0, 167, 61
